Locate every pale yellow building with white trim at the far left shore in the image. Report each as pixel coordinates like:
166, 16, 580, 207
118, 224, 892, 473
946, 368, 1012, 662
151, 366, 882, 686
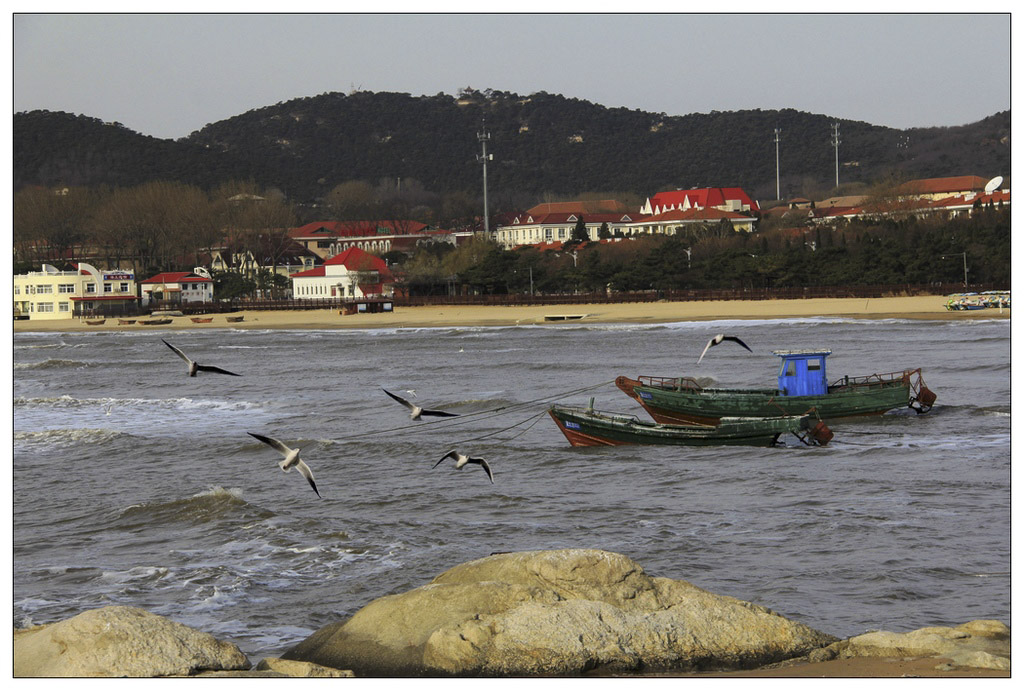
14, 262, 138, 319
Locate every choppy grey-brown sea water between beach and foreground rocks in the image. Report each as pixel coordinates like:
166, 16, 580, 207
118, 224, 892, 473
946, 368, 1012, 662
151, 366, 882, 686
13, 319, 1011, 660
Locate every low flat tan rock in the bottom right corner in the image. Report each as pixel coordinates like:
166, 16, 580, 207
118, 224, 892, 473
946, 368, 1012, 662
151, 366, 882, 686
821, 619, 1010, 670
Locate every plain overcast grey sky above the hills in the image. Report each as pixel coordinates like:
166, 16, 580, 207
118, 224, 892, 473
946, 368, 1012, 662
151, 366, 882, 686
13, 13, 1010, 138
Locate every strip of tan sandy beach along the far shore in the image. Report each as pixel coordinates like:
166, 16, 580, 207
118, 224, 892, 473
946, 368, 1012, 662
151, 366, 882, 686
14, 295, 1010, 332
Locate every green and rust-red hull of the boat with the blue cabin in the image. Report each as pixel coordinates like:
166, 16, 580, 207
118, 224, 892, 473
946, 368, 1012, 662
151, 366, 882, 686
615, 371, 934, 425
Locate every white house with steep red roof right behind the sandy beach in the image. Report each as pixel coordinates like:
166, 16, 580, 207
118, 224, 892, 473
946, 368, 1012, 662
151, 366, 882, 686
292, 247, 394, 300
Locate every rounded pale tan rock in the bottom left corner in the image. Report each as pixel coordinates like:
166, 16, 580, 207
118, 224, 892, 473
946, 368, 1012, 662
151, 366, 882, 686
14, 606, 251, 677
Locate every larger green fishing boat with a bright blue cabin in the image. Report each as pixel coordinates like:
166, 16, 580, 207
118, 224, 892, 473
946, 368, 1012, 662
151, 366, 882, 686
615, 350, 936, 425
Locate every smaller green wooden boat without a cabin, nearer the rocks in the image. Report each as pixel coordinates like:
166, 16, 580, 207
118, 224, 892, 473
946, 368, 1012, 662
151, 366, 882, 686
548, 405, 833, 446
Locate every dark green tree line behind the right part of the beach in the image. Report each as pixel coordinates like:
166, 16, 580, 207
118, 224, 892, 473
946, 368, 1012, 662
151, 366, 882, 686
392, 208, 1010, 295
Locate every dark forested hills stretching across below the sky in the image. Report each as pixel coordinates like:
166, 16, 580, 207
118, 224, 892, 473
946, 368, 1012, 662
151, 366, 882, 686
14, 90, 1010, 205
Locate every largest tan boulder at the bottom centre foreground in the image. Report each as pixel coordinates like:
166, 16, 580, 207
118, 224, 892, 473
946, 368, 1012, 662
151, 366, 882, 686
283, 550, 837, 677
